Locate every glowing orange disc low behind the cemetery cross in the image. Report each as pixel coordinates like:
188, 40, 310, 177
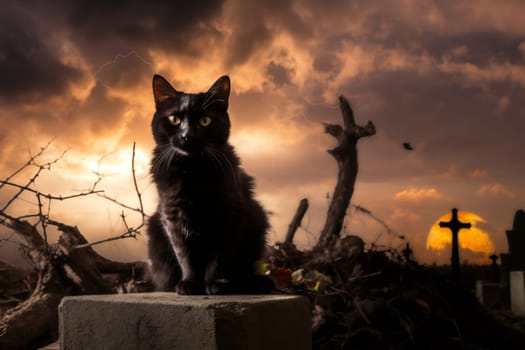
426, 211, 494, 263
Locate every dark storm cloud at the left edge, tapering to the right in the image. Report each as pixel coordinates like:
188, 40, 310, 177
0, 6, 86, 103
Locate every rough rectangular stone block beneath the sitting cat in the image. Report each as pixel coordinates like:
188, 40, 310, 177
59, 293, 311, 350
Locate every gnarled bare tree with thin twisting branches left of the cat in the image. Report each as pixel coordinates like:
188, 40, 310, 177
0, 142, 146, 349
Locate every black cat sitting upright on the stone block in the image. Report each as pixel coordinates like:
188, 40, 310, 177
148, 75, 273, 294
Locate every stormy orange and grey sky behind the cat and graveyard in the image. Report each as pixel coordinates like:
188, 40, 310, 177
0, 0, 525, 263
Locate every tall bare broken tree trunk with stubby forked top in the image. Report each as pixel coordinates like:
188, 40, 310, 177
315, 96, 376, 250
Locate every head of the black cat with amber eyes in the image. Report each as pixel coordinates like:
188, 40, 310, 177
151, 75, 230, 157
